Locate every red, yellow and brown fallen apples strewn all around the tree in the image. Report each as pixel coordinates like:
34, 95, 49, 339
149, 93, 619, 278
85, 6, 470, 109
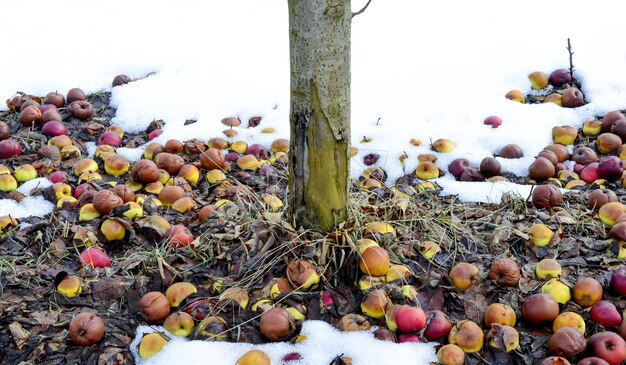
0, 73, 626, 364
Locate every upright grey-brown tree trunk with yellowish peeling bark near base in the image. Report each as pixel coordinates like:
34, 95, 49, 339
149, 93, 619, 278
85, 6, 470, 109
288, 0, 352, 230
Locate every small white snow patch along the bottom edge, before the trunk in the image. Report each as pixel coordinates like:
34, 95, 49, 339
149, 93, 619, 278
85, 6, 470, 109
130, 321, 435, 365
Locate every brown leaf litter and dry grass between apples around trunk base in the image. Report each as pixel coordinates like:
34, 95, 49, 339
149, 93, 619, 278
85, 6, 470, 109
0, 89, 626, 364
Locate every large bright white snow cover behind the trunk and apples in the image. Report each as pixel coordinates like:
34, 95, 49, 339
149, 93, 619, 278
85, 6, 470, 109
0, 0, 626, 364
